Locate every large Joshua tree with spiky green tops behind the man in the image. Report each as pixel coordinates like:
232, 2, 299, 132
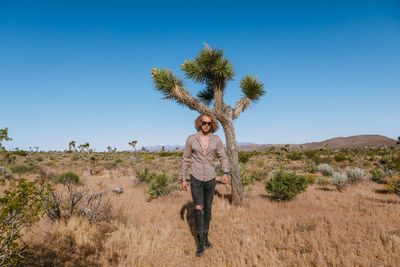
151, 44, 265, 205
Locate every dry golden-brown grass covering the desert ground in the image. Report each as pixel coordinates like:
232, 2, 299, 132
2, 151, 400, 266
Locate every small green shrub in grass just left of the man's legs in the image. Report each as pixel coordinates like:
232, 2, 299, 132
146, 173, 179, 201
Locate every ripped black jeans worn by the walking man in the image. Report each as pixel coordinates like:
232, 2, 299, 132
190, 175, 216, 234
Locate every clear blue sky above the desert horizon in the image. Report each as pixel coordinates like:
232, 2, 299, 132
0, 0, 400, 151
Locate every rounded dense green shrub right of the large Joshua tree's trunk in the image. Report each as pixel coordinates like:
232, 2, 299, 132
265, 169, 308, 200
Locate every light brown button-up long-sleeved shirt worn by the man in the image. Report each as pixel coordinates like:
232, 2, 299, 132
181, 132, 229, 181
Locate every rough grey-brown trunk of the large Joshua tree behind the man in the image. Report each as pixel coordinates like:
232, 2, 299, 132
220, 118, 243, 206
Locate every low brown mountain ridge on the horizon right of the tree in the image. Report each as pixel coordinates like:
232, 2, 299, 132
238, 135, 396, 151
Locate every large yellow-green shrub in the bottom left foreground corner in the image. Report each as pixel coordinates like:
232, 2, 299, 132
0, 178, 51, 266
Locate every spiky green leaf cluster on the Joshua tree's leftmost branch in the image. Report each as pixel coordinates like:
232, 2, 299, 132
151, 68, 183, 97
